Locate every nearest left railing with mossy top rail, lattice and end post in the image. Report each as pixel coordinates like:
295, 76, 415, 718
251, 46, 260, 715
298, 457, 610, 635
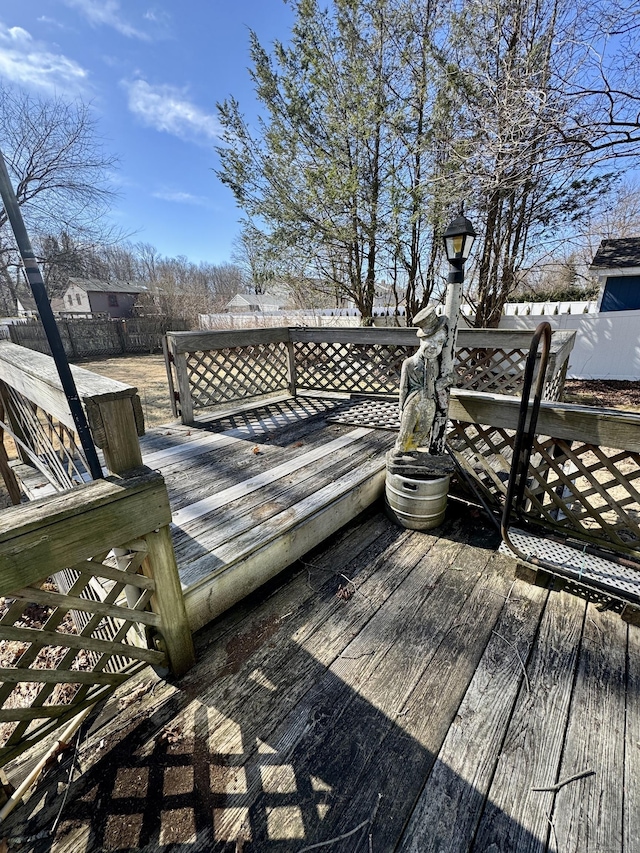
0, 468, 194, 765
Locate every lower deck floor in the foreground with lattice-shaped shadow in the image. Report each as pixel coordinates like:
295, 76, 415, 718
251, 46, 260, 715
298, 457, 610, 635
2, 507, 640, 853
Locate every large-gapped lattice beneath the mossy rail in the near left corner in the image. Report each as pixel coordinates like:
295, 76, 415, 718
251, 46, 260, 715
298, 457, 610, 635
0, 540, 165, 765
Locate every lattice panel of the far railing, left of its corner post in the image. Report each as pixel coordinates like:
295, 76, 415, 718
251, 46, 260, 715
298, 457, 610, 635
187, 342, 289, 408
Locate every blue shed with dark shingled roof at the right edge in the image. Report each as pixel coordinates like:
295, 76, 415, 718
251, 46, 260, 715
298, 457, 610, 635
589, 237, 640, 312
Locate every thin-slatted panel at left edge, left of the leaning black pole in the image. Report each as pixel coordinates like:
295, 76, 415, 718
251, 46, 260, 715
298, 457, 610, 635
0, 385, 94, 492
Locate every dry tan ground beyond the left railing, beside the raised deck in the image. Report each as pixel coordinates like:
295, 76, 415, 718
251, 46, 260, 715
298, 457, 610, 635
75, 354, 174, 426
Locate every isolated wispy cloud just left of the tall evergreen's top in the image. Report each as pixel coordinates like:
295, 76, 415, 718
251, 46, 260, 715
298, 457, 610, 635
124, 80, 221, 141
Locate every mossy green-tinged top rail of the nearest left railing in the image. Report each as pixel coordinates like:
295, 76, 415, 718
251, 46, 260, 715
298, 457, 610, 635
0, 471, 171, 595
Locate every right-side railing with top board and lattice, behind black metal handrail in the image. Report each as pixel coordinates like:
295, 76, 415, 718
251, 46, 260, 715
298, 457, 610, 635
447, 390, 640, 559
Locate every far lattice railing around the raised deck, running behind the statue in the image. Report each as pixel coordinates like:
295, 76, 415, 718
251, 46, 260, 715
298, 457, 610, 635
166, 327, 575, 423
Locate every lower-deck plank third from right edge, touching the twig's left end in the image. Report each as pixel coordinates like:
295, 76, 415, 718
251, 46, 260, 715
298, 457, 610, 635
472, 592, 586, 853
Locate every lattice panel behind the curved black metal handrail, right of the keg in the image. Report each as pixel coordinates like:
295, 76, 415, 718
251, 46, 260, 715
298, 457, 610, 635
448, 422, 640, 554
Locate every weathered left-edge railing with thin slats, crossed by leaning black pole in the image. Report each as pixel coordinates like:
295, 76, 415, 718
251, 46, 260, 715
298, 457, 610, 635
0, 341, 144, 498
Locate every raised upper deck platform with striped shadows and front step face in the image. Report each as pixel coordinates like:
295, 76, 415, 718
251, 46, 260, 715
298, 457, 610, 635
141, 395, 395, 630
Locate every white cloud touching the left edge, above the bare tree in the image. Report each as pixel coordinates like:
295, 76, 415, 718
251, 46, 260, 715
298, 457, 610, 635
0, 22, 88, 93
